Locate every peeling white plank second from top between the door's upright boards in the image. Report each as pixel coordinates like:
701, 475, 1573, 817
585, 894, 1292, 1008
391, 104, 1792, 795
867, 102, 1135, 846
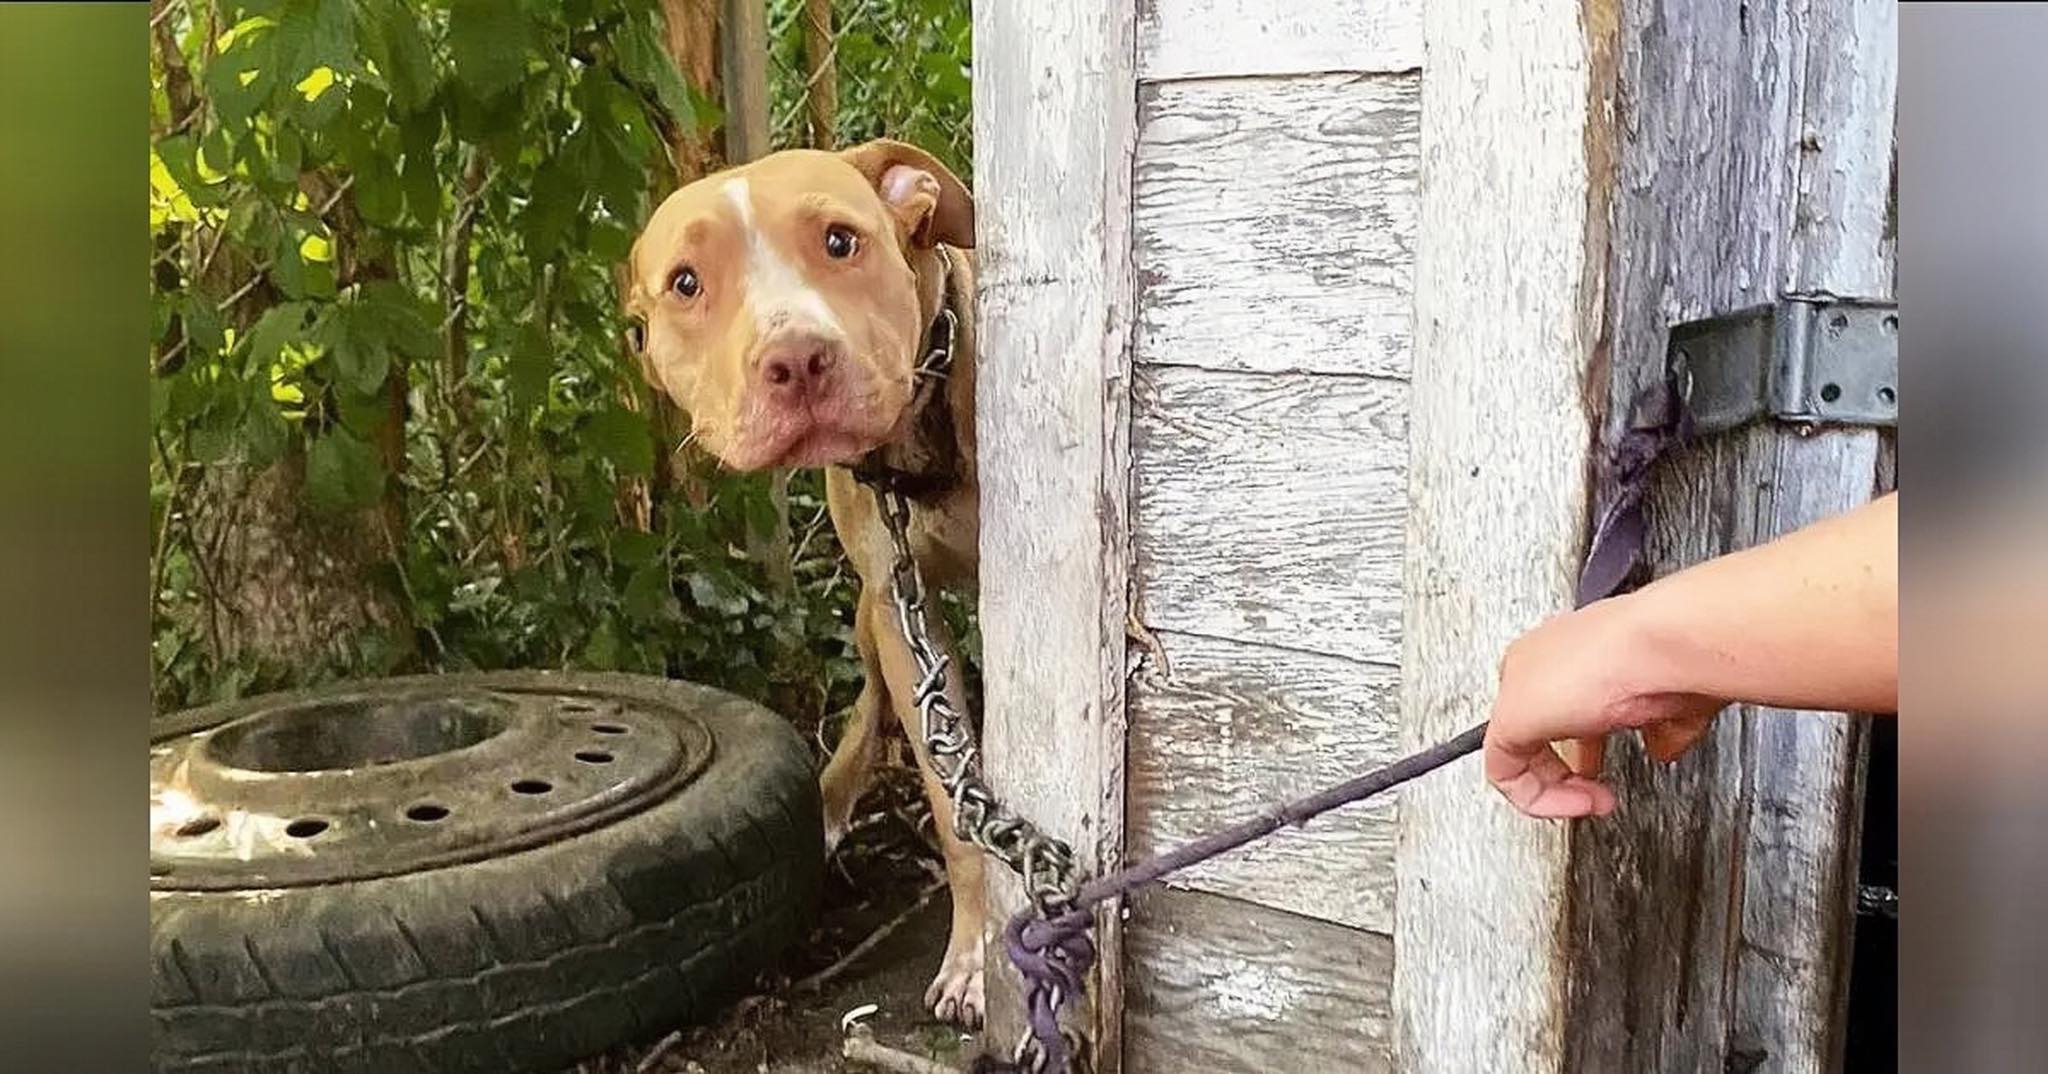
1135, 74, 1421, 377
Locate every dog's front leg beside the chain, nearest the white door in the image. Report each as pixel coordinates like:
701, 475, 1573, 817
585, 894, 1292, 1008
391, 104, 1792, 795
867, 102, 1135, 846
874, 582, 987, 1029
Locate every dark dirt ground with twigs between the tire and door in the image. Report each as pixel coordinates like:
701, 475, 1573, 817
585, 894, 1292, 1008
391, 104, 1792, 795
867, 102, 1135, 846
563, 750, 979, 1074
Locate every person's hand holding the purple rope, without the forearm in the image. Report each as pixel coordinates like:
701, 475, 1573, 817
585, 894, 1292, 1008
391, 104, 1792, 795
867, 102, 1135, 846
1485, 596, 1726, 818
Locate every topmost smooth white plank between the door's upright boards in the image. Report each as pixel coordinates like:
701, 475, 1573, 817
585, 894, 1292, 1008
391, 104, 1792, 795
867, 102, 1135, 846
1139, 0, 1421, 80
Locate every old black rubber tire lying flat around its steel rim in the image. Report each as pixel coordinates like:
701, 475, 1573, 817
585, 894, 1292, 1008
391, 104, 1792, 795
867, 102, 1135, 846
150, 672, 823, 1074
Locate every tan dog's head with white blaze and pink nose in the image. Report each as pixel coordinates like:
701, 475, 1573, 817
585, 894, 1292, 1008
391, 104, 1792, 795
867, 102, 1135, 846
627, 141, 975, 469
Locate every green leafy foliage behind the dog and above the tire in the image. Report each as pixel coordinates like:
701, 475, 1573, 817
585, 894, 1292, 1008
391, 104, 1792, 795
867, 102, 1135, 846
150, 0, 969, 717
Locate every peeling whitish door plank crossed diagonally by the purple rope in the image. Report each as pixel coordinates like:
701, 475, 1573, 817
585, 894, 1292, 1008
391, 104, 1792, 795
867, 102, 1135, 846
1126, 631, 1399, 933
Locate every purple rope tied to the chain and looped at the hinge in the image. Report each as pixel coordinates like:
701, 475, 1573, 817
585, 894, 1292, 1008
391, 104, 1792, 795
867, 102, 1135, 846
973, 381, 1692, 1074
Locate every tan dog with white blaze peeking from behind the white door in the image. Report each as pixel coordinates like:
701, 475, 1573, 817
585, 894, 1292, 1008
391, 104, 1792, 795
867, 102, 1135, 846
627, 141, 985, 1025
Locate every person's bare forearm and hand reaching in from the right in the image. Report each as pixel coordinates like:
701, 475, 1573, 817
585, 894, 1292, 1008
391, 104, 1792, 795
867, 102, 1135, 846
1485, 494, 1898, 818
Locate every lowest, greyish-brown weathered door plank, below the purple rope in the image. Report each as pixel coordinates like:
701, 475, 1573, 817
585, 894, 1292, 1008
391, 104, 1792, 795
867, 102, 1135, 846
1126, 890, 1397, 1074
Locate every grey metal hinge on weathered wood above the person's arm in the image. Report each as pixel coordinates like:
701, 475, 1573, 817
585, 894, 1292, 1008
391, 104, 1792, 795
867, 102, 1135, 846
1667, 295, 1898, 432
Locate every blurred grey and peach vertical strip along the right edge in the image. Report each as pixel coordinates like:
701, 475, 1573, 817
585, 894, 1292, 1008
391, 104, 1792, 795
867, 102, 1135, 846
1898, 4, 2048, 1072
